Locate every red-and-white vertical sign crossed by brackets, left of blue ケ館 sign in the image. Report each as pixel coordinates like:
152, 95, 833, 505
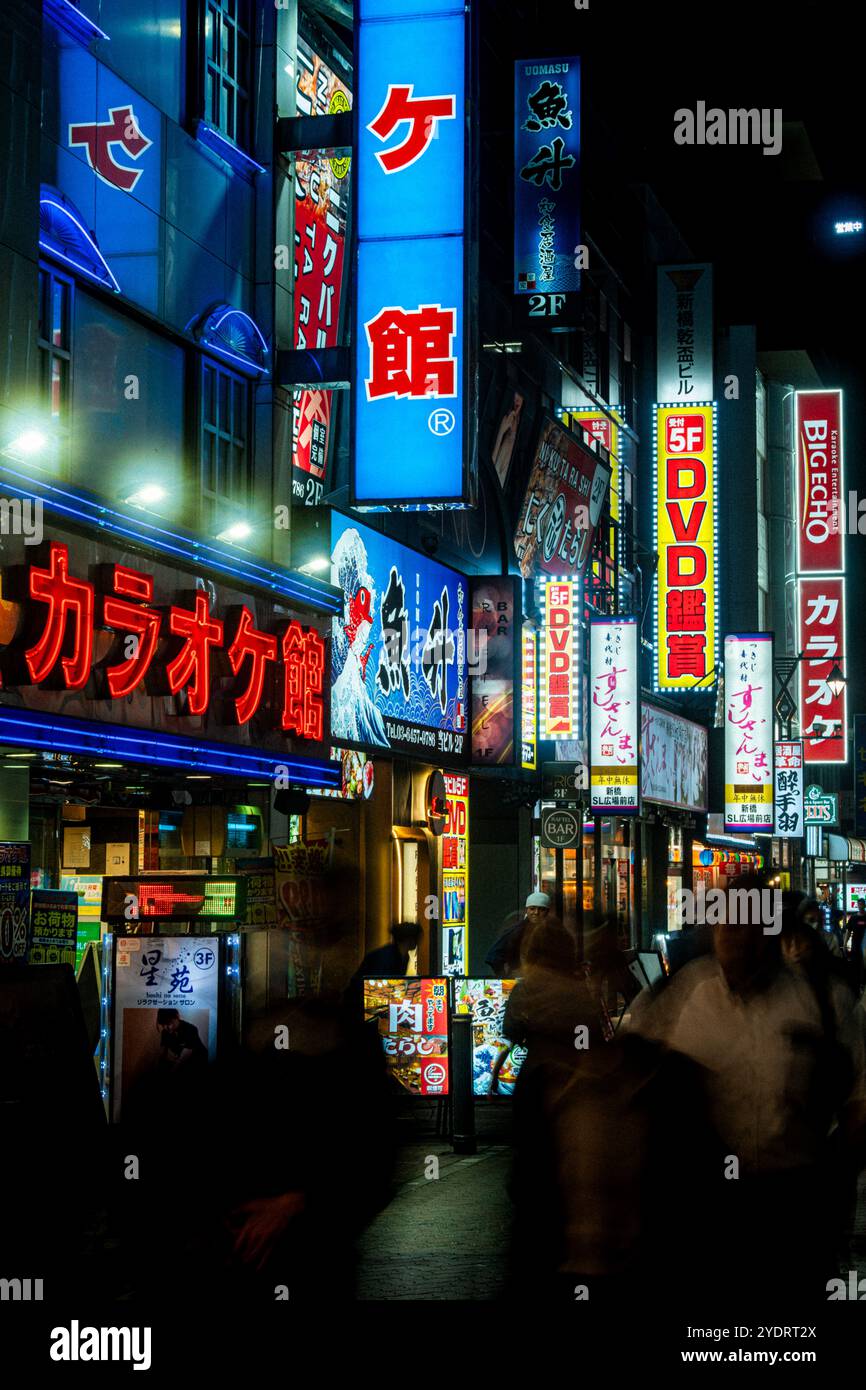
292, 35, 352, 506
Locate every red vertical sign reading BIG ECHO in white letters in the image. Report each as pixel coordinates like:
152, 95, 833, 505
794, 391, 845, 574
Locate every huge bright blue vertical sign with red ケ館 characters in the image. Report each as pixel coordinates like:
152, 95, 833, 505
350, 0, 477, 510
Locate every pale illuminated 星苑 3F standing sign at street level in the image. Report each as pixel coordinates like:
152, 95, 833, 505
111, 937, 220, 1120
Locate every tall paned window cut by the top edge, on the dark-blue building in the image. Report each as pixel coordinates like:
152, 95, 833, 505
204, 0, 250, 149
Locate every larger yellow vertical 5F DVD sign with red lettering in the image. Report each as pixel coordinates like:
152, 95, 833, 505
655, 406, 717, 689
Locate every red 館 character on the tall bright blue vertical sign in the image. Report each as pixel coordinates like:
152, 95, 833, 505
364, 304, 457, 400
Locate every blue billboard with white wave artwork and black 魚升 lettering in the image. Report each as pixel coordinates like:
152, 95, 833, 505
331, 512, 468, 762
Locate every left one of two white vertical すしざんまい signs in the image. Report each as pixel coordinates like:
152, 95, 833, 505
589, 617, 639, 816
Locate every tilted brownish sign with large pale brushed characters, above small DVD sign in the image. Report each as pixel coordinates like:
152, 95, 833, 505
514, 416, 610, 580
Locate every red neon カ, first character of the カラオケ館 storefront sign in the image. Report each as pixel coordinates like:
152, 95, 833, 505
24, 541, 93, 691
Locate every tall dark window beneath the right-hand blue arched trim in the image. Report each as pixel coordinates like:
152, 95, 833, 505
200, 357, 250, 524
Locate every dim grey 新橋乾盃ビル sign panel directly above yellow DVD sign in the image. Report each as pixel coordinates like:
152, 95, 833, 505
656, 264, 714, 404
